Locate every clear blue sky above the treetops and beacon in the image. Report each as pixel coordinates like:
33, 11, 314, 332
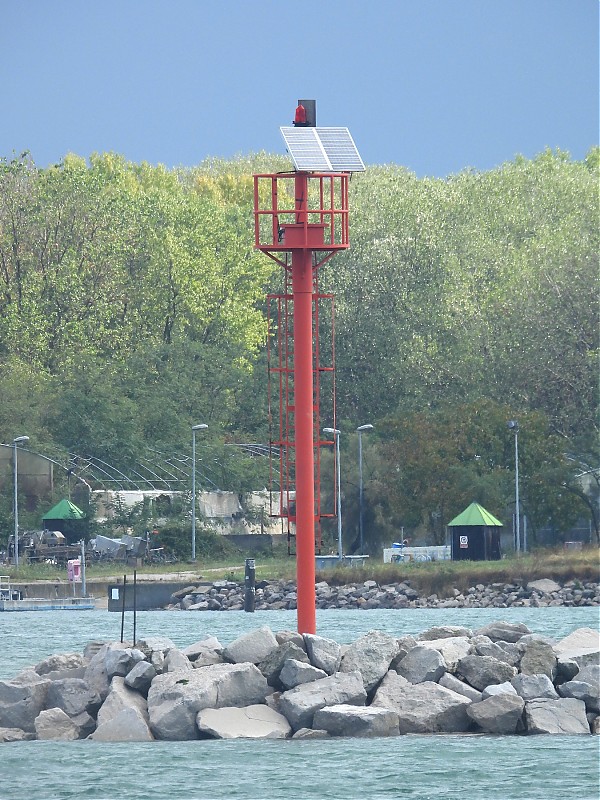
0, 0, 599, 176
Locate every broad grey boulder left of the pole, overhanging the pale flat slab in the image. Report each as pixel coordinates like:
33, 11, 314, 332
148, 664, 269, 741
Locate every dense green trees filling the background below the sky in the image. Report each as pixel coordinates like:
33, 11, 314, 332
0, 149, 599, 546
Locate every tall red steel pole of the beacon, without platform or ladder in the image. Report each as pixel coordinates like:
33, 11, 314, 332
292, 173, 316, 633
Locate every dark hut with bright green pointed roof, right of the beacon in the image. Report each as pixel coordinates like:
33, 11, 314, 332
448, 503, 503, 561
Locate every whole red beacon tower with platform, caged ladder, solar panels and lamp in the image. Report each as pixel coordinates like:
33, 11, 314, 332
254, 100, 365, 633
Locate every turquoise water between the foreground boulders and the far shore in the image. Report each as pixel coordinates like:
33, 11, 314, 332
0, 607, 600, 680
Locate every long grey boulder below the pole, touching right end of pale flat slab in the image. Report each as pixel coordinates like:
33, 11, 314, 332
279, 672, 367, 731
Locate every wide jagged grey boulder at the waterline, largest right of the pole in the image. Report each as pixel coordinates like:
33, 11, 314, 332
372, 673, 472, 733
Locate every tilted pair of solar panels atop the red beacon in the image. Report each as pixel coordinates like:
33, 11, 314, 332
280, 127, 365, 172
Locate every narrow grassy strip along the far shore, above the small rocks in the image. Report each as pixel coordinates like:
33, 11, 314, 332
0, 547, 600, 596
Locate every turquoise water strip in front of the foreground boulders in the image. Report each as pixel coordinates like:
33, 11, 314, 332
0, 736, 598, 800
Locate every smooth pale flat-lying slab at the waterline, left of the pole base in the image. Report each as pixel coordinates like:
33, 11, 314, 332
196, 705, 292, 739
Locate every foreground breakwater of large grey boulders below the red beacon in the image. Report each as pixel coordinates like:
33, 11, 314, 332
0, 622, 600, 742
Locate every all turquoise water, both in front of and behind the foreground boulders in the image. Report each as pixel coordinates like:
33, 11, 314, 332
0, 608, 600, 800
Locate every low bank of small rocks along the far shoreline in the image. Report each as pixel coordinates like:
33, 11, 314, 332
167, 578, 600, 611
